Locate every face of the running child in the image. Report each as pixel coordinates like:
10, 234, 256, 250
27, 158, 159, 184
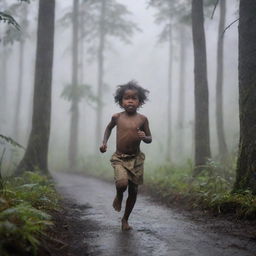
122, 90, 140, 113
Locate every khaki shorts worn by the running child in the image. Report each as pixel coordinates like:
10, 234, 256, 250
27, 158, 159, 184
110, 152, 145, 185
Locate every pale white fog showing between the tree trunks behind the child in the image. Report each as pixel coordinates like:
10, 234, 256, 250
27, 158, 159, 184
0, 0, 239, 172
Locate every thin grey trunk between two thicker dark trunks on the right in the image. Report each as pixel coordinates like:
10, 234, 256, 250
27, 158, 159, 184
216, 0, 228, 161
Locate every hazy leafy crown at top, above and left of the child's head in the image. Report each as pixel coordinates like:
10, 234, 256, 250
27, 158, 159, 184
58, 0, 141, 54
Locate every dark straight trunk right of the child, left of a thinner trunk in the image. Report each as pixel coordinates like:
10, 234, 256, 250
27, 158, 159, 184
192, 0, 211, 175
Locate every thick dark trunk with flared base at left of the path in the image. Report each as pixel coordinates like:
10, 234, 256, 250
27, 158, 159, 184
17, 0, 55, 174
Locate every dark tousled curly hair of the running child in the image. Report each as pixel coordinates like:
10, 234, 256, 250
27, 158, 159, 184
114, 80, 149, 107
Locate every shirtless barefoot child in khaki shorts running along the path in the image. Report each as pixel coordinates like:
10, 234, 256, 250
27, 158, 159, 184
100, 81, 152, 230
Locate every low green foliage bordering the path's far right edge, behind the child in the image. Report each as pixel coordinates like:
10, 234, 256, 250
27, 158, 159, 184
83, 156, 256, 220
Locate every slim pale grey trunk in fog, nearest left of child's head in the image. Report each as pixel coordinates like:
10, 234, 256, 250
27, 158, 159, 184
95, 1, 106, 153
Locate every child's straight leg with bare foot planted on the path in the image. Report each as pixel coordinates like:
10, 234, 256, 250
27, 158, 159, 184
122, 180, 138, 230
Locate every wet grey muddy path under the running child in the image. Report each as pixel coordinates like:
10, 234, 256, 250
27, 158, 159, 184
48, 174, 256, 256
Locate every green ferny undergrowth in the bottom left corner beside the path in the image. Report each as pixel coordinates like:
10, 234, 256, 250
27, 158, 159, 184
0, 172, 58, 256
